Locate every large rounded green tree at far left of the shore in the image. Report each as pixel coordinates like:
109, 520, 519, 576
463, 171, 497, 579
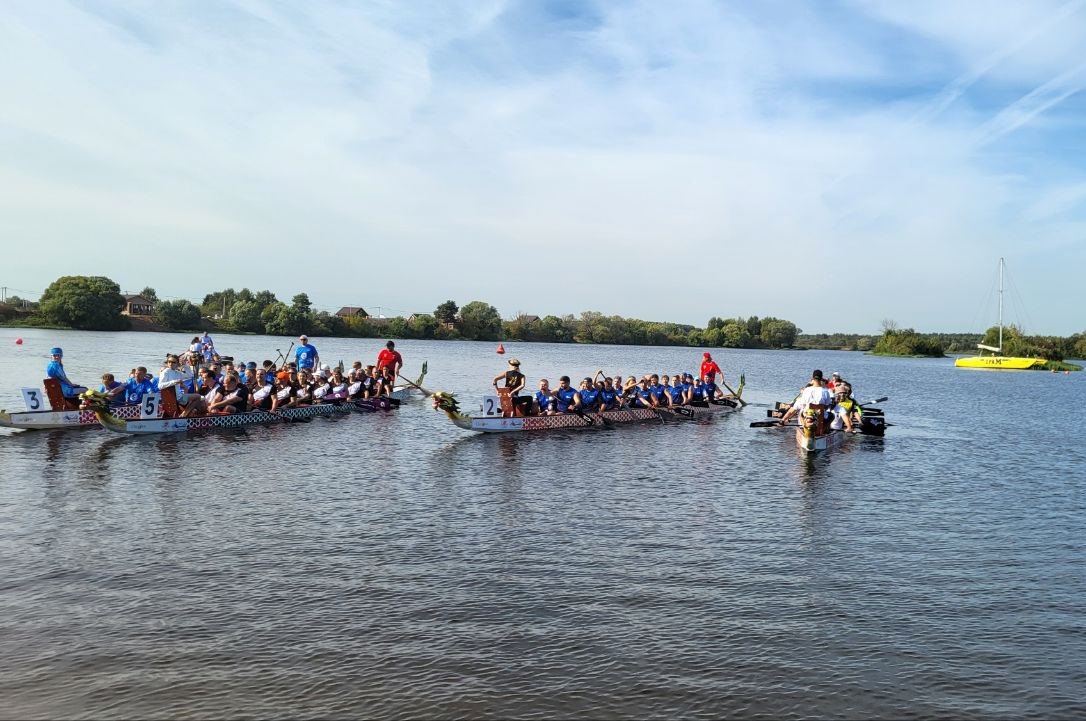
39, 276, 128, 330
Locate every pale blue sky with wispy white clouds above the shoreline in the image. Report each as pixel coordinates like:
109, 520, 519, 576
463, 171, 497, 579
0, 0, 1086, 334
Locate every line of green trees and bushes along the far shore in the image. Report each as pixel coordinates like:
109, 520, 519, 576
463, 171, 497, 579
0, 276, 1086, 359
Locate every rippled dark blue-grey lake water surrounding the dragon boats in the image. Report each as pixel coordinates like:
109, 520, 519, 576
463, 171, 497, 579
0, 329, 1086, 719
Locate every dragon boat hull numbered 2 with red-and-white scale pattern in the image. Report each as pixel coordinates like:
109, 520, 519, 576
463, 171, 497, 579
432, 376, 745, 433
